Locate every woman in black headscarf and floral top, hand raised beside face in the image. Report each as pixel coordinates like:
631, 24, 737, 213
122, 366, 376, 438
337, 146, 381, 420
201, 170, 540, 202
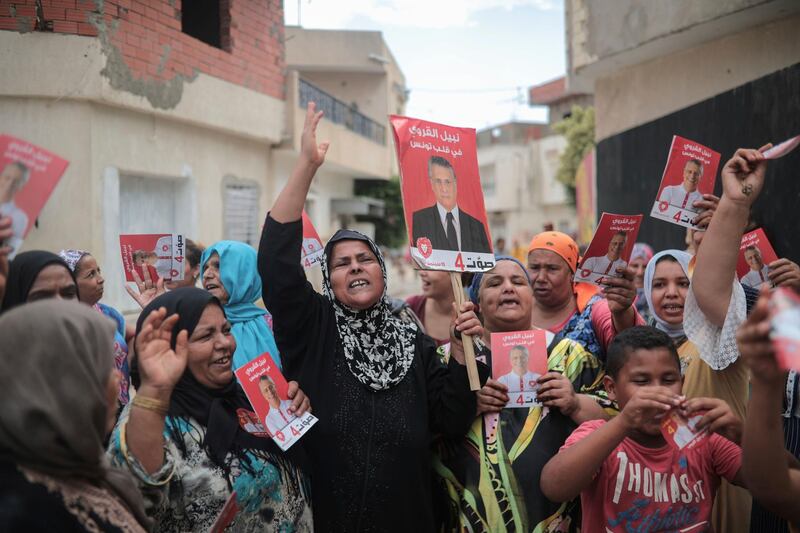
109, 288, 313, 532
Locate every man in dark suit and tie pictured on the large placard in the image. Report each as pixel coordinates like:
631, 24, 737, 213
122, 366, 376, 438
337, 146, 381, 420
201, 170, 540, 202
411, 156, 491, 253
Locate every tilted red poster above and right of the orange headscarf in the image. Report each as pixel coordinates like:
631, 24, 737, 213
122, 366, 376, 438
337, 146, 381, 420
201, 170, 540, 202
575, 213, 643, 285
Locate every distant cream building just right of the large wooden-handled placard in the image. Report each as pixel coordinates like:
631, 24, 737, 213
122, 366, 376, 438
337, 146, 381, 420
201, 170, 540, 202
478, 122, 575, 248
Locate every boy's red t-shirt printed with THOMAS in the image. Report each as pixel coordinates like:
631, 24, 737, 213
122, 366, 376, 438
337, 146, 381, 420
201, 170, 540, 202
562, 420, 742, 533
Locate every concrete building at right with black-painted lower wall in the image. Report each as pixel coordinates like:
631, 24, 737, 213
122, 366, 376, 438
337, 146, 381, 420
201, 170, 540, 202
565, 0, 800, 254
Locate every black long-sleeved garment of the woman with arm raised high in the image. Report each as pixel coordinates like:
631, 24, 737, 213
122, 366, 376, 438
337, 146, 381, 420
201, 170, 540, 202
258, 216, 488, 533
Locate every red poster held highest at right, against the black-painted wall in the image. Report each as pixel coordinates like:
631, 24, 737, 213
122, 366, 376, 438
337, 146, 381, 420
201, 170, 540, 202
650, 135, 720, 229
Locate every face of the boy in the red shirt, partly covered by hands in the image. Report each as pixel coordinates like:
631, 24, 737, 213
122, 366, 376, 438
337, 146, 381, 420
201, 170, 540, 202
604, 348, 683, 436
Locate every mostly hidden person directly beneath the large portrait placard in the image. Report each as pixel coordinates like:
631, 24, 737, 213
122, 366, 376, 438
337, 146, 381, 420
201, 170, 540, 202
406, 270, 456, 346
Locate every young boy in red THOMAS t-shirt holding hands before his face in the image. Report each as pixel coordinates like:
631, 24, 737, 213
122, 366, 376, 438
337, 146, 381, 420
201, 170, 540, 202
541, 326, 743, 533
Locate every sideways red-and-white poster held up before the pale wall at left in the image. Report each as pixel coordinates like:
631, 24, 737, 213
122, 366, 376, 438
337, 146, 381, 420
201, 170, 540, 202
119, 233, 186, 281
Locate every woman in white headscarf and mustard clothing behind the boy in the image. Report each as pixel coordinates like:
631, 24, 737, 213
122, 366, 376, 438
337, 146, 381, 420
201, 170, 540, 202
644, 250, 752, 533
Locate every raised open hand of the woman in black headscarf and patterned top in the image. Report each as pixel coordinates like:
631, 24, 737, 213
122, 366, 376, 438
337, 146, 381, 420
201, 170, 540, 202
136, 307, 189, 396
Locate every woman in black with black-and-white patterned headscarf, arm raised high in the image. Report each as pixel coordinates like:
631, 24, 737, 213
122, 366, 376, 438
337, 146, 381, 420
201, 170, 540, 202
259, 103, 486, 532
